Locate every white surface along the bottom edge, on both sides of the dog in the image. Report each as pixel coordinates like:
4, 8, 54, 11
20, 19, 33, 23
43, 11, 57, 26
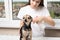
0, 35, 60, 40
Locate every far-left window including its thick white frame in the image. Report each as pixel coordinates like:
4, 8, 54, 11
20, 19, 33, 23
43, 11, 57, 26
0, 0, 9, 21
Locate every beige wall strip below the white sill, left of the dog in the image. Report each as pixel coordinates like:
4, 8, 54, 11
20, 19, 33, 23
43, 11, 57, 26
0, 28, 19, 36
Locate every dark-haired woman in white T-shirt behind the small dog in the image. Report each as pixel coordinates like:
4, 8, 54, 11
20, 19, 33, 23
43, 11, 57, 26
17, 0, 55, 37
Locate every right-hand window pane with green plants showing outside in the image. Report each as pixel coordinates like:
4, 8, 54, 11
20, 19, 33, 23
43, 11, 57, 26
47, 0, 60, 19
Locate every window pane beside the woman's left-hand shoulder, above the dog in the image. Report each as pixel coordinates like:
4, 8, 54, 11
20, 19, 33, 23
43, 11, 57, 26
12, 0, 27, 20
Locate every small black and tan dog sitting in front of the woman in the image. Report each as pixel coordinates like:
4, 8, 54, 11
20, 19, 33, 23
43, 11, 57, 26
20, 15, 32, 40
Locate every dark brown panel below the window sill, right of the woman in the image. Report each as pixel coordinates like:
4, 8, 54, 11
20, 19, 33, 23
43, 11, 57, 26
45, 27, 60, 37
